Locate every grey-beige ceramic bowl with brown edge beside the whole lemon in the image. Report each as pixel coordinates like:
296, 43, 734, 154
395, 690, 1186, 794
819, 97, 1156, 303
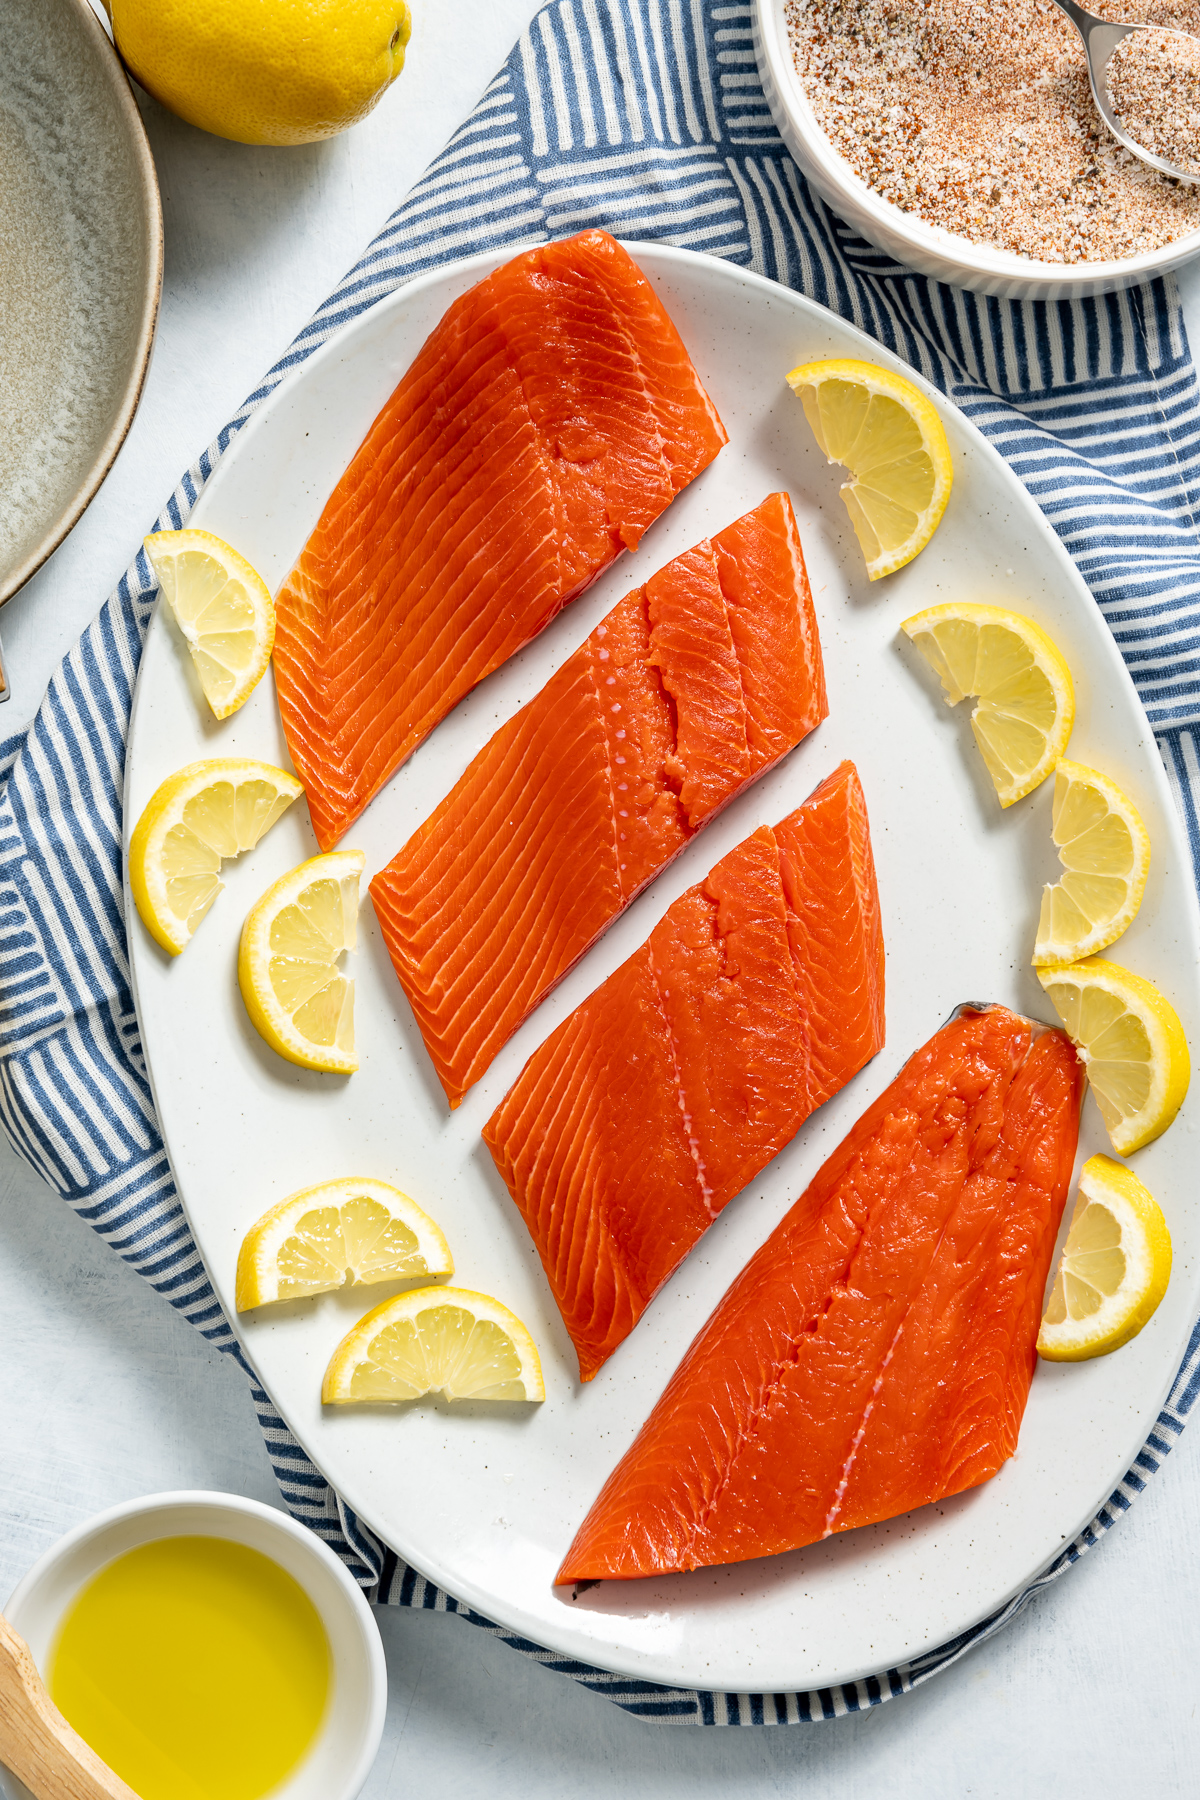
0, 0, 162, 603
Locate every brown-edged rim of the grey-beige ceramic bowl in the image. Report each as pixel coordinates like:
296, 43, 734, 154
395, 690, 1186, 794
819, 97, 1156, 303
0, 0, 162, 607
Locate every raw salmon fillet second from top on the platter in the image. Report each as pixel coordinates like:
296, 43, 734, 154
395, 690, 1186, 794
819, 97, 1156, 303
371, 493, 828, 1107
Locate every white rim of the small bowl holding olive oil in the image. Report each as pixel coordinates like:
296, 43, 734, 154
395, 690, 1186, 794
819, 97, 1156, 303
0, 1489, 387, 1800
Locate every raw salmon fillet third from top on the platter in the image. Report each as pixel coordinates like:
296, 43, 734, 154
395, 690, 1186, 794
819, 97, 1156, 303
484, 763, 883, 1381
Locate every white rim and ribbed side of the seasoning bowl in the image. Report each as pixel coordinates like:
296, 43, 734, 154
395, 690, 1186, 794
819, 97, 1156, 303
752, 0, 1200, 301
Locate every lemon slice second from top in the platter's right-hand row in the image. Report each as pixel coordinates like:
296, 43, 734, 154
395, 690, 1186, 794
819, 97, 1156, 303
900, 601, 1076, 806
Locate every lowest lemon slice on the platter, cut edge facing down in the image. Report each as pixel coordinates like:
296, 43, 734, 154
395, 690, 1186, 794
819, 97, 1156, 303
320, 1287, 545, 1406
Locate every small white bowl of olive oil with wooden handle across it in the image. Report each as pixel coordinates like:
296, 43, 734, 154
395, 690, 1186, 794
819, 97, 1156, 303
0, 1492, 387, 1800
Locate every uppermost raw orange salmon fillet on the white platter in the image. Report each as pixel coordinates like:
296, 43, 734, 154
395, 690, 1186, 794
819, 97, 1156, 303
275, 230, 727, 850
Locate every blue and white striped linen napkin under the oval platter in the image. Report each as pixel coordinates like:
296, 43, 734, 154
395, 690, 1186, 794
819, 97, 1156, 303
0, 0, 1200, 1724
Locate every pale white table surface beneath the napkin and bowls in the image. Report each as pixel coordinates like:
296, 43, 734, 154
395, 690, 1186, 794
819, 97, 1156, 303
0, 10, 1200, 1800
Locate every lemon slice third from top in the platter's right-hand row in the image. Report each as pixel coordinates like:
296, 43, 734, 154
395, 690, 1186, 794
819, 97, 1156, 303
1033, 761, 1150, 968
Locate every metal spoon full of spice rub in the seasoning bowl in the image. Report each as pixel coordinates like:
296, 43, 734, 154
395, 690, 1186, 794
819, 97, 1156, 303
1058, 0, 1200, 182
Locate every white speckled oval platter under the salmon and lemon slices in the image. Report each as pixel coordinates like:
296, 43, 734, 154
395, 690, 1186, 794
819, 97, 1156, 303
126, 245, 1200, 1692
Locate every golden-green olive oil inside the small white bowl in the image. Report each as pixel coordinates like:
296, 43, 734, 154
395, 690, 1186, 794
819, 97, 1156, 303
47, 1537, 331, 1800
